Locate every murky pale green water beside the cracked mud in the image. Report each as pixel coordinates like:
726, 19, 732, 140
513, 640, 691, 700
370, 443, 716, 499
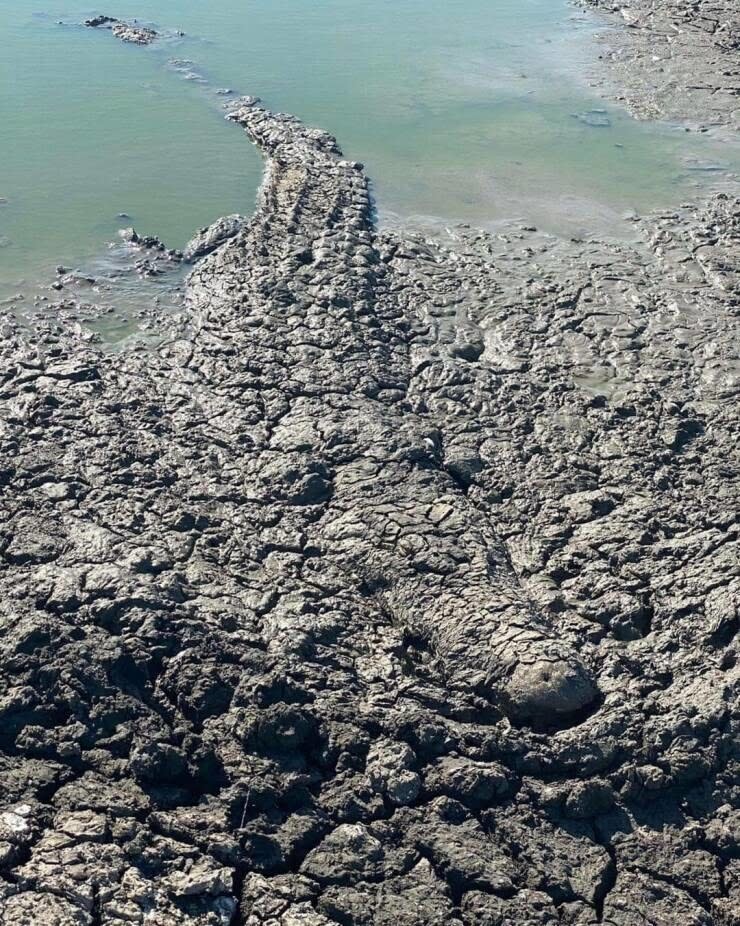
0, 0, 740, 292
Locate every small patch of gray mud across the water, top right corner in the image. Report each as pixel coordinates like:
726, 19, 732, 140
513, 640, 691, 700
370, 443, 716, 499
579, 0, 740, 132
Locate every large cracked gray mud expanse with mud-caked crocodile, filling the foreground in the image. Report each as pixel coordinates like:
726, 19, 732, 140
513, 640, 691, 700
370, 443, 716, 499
0, 89, 740, 926
